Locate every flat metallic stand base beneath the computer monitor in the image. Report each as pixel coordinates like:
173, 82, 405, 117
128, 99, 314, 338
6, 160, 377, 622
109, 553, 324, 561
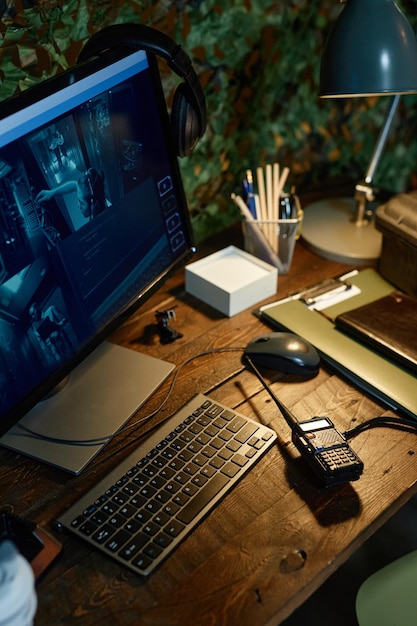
0, 342, 174, 474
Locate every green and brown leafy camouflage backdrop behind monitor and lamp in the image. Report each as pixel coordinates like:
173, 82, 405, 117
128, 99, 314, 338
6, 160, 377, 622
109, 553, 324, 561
0, 0, 417, 239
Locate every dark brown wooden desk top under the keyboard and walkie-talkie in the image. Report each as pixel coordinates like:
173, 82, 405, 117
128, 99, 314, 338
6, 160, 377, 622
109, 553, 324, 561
0, 227, 417, 626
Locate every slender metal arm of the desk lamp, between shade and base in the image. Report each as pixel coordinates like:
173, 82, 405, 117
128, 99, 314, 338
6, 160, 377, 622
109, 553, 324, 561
355, 94, 400, 226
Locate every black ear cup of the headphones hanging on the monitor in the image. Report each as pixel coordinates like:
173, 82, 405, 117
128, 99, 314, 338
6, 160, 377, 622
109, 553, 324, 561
171, 83, 201, 157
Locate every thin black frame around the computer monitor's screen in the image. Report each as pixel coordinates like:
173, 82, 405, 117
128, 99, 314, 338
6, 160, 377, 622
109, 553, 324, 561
0, 48, 196, 435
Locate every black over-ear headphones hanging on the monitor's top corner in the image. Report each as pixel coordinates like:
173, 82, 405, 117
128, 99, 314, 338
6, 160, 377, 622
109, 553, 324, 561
78, 24, 206, 157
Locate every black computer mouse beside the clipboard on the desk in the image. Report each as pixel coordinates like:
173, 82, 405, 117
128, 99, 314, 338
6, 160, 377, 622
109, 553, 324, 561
244, 332, 320, 376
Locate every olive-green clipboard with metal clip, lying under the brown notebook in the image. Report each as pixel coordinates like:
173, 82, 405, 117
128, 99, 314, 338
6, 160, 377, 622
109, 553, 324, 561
257, 269, 417, 418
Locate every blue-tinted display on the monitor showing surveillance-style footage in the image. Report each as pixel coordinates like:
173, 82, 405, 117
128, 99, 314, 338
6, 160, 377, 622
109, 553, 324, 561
0, 51, 190, 432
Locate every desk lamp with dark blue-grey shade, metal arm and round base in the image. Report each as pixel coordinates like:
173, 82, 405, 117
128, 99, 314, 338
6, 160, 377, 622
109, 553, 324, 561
302, 0, 417, 265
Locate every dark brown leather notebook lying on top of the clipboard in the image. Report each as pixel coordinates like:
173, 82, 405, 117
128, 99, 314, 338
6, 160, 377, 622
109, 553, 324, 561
335, 291, 417, 374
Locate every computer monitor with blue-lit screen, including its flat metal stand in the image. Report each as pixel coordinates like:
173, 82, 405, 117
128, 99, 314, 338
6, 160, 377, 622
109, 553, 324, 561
0, 50, 194, 474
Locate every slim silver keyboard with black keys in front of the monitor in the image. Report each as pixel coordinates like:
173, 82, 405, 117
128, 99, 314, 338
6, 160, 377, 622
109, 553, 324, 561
57, 394, 277, 576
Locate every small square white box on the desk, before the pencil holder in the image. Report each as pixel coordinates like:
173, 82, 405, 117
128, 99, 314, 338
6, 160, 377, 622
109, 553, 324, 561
185, 246, 278, 317
